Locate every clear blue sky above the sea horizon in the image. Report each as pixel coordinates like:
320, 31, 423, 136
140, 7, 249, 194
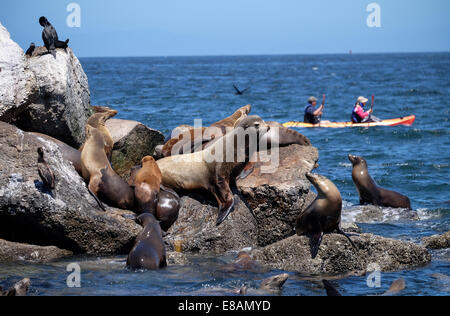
0, 0, 450, 57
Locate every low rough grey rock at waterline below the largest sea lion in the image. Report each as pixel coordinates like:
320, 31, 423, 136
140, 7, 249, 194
164, 195, 257, 254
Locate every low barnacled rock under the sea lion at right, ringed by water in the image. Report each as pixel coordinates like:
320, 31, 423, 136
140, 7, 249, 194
252, 234, 431, 275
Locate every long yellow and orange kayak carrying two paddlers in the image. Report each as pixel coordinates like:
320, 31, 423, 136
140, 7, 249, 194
283, 115, 416, 128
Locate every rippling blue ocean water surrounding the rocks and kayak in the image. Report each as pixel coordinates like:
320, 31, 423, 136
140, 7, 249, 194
0, 53, 450, 296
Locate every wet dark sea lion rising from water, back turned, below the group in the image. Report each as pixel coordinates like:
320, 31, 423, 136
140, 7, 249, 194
127, 213, 167, 270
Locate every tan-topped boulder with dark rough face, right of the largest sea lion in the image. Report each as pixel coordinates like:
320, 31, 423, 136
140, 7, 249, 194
237, 145, 319, 247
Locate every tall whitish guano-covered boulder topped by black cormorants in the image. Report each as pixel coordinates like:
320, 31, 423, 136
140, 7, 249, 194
0, 25, 91, 147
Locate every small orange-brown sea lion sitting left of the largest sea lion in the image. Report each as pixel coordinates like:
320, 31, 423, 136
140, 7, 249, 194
134, 156, 162, 215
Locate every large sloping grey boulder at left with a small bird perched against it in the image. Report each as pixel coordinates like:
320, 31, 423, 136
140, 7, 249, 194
0, 122, 142, 254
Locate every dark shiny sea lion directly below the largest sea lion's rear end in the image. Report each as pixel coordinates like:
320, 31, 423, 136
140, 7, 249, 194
156, 185, 181, 231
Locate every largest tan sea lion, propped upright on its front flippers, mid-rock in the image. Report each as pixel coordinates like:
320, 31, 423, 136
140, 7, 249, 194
157, 116, 270, 225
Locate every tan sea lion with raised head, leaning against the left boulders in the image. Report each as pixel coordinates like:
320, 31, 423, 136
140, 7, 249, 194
81, 124, 134, 210
